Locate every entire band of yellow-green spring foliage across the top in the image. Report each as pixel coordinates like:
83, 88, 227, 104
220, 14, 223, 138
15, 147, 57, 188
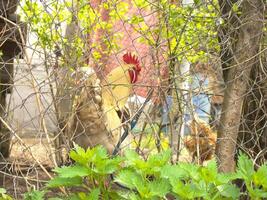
20, 0, 220, 67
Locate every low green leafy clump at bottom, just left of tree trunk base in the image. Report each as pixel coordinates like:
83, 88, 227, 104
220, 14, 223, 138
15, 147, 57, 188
162, 161, 239, 199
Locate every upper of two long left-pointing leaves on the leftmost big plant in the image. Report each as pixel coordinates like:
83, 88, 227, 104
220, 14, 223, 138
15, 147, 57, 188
53, 165, 92, 178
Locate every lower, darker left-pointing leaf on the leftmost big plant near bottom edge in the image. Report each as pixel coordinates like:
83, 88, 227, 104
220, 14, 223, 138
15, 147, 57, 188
47, 176, 83, 188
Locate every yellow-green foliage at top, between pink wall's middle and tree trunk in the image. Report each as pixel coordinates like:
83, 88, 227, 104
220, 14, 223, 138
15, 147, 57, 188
130, 0, 219, 63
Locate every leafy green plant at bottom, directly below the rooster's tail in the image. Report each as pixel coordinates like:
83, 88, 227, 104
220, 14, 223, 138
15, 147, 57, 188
47, 146, 122, 199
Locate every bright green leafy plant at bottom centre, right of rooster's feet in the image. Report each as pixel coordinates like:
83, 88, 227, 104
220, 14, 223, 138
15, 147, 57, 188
115, 150, 171, 199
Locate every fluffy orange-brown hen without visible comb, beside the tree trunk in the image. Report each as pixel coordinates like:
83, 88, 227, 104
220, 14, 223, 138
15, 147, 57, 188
184, 118, 217, 164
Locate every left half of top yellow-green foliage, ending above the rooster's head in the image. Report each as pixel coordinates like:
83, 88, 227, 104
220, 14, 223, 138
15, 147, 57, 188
19, 0, 128, 68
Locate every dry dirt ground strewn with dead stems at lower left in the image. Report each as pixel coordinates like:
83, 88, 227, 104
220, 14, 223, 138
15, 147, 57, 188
0, 138, 53, 199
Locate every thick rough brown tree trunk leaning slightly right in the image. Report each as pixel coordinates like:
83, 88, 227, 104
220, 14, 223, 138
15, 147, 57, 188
216, 0, 264, 172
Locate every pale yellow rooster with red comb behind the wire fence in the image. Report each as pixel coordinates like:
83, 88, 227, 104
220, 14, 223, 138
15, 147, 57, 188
67, 53, 141, 153
